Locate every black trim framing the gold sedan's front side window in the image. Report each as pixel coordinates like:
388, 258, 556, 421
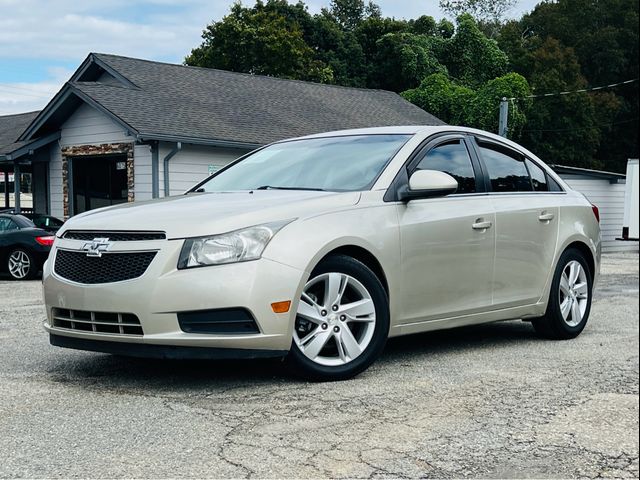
383, 131, 489, 202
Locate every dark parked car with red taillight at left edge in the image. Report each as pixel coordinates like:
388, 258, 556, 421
0, 214, 55, 280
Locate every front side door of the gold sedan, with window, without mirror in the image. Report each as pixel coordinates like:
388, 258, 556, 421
398, 137, 495, 324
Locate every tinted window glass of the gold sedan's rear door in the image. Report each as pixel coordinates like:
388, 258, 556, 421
479, 144, 532, 192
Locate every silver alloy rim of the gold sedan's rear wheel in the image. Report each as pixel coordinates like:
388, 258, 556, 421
558, 260, 589, 327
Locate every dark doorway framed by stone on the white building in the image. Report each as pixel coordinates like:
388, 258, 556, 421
71, 155, 128, 215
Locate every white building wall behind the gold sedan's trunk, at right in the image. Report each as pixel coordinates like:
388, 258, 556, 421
561, 175, 638, 253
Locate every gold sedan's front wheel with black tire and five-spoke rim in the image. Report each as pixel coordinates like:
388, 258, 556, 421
287, 255, 389, 381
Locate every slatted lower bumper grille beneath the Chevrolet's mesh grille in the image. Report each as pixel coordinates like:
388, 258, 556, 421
51, 308, 143, 335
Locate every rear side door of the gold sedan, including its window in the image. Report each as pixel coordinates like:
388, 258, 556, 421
476, 138, 559, 308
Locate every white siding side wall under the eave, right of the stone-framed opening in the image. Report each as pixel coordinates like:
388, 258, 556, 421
158, 142, 248, 197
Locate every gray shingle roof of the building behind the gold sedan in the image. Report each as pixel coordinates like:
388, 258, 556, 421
71, 54, 444, 144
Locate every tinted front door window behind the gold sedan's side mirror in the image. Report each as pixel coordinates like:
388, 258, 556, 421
416, 140, 476, 193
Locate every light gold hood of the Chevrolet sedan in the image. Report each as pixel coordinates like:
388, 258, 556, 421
58, 190, 360, 238
